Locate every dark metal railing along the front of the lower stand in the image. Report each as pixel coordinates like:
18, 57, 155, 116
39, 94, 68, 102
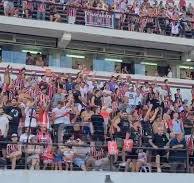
0, 141, 193, 173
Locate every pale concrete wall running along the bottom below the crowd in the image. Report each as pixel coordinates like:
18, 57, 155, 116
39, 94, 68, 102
0, 170, 194, 183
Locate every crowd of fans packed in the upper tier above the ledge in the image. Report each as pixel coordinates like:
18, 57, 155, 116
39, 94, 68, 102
3, 0, 194, 38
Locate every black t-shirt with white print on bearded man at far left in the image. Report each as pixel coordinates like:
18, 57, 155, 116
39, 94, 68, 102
4, 106, 22, 127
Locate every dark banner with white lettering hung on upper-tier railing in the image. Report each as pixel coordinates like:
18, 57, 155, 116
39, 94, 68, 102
85, 10, 114, 29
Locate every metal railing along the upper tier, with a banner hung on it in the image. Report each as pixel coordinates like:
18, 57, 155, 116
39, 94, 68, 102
1, 0, 194, 38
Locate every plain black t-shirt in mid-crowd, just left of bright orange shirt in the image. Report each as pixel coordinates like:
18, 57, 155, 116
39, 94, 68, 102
91, 114, 104, 134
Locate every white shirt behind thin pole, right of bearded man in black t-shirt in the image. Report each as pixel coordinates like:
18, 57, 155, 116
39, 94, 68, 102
25, 107, 37, 128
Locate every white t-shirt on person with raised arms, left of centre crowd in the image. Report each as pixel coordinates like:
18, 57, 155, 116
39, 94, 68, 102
52, 107, 70, 125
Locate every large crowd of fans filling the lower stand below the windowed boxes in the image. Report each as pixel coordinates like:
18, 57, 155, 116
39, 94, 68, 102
0, 66, 194, 172
